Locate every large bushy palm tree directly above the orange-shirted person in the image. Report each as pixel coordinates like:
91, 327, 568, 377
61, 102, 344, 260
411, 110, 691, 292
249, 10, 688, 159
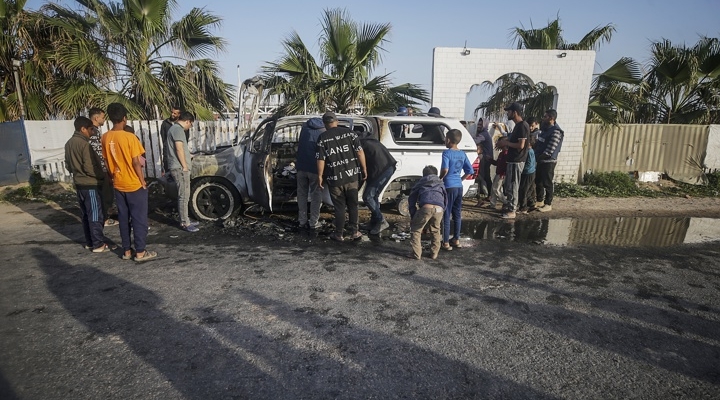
54, 0, 233, 119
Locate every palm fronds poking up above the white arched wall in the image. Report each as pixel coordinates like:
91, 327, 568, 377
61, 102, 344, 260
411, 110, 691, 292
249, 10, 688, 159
510, 17, 615, 50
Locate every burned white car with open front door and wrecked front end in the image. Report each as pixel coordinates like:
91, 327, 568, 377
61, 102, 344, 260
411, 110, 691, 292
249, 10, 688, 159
173, 115, 476, 220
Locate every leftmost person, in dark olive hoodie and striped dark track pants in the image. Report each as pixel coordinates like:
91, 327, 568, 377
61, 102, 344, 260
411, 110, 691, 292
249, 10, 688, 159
65, 117, 110, 253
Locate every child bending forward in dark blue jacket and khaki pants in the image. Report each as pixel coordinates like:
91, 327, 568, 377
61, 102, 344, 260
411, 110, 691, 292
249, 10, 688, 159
407, 165, 447, 260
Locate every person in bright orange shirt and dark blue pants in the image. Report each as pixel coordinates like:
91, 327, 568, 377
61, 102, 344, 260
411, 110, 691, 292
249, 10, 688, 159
102, 103, 157, 262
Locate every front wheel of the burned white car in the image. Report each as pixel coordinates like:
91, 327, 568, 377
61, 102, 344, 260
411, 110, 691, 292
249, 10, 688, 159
190, 178, 240, 221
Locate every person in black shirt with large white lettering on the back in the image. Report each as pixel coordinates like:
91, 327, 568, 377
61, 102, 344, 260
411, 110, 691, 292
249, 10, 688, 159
316, 112, 367, 242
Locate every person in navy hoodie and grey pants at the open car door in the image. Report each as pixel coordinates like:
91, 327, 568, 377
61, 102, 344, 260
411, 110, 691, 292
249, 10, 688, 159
295, 118, 325, 229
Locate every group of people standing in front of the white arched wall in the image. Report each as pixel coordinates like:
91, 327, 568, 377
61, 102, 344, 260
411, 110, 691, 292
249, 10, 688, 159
475, 103, 564, 219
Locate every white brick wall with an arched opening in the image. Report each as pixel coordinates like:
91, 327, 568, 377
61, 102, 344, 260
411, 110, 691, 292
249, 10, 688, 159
432, 47, 595, 182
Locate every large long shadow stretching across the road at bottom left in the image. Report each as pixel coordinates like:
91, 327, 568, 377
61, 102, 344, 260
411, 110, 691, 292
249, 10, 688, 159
30, 248, 552, 399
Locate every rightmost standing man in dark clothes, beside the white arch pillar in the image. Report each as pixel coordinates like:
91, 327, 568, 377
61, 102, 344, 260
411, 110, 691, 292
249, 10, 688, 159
535, 109, 565, 212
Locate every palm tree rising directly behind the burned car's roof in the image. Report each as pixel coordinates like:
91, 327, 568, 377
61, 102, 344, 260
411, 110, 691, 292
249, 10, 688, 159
263, 9, 429, 113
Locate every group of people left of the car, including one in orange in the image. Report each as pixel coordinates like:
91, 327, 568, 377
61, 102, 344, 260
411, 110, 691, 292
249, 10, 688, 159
65, 103, 198, 262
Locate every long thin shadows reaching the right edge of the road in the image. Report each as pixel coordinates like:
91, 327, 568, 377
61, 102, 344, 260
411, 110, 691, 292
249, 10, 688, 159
398, 271, 720, 384
